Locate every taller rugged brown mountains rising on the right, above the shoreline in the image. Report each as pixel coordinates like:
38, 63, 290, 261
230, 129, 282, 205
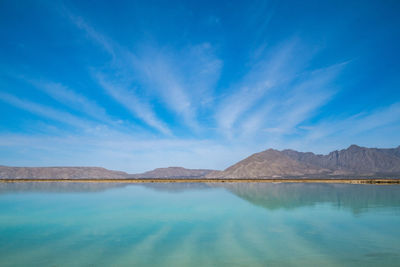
206, 145, 400, 178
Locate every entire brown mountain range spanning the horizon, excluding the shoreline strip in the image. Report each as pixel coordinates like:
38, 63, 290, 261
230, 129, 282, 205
0, 145, 400, 179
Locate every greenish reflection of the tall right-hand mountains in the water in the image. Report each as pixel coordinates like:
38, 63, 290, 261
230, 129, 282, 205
217, 183, 400, 216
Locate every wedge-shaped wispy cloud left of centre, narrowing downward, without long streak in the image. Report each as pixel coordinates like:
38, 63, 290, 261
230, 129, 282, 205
133, 43, 222, 130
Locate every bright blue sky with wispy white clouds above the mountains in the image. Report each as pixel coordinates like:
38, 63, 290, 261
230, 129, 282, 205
0, 0, 400, 173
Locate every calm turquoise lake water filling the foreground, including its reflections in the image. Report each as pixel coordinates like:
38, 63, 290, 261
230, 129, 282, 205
0, 183, 400, 266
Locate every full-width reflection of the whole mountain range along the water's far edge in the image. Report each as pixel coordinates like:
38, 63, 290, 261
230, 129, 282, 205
0, 182, 400, 214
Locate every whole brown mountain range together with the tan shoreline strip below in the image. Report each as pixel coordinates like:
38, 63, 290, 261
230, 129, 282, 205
0, 145, 400, 183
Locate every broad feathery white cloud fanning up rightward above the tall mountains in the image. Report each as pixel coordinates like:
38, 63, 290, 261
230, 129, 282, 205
216, 39, 346, 141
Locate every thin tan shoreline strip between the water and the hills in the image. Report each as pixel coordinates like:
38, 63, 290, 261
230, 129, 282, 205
0, 178, 400, 185
